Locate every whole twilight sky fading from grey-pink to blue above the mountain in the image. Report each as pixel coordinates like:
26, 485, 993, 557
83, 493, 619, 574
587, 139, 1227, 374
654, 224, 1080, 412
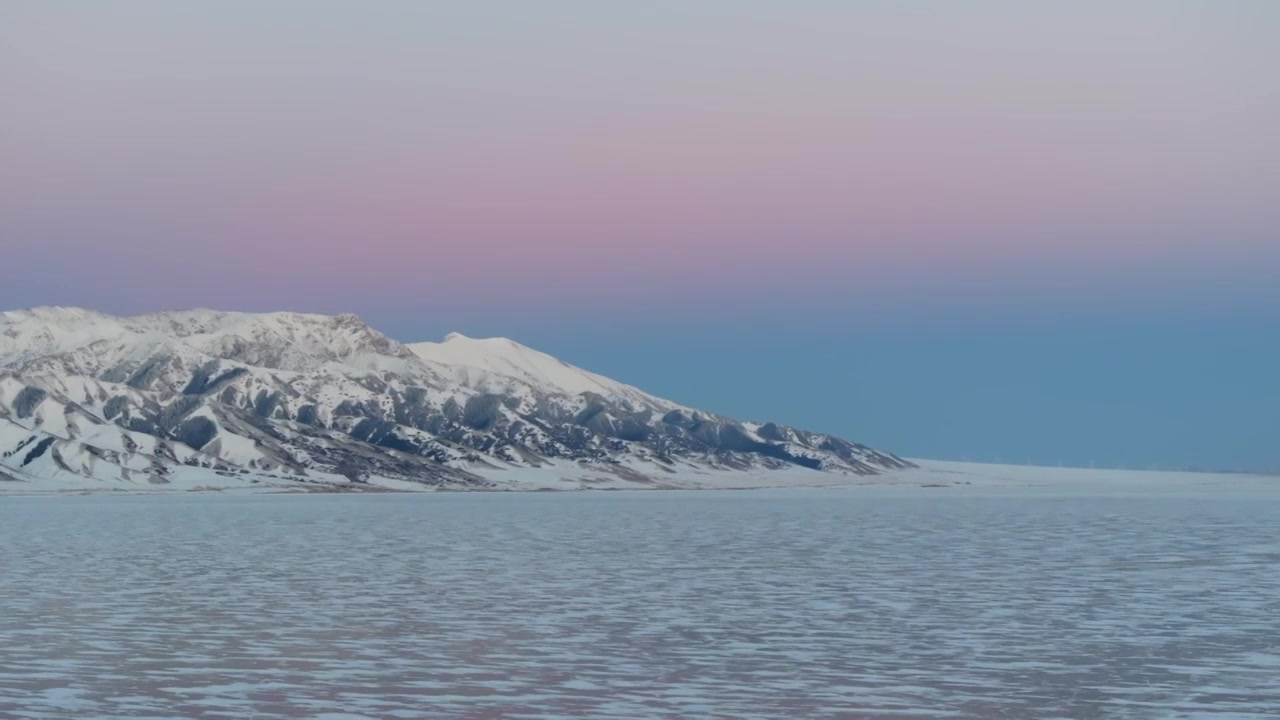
0, 0, 1280, 470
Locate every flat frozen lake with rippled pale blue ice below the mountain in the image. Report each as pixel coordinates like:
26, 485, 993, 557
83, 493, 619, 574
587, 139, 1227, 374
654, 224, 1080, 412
0, 488, 1280, 720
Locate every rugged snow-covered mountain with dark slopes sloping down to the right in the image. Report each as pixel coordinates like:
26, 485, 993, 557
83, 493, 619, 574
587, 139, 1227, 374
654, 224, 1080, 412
0, 307, 910, 489
